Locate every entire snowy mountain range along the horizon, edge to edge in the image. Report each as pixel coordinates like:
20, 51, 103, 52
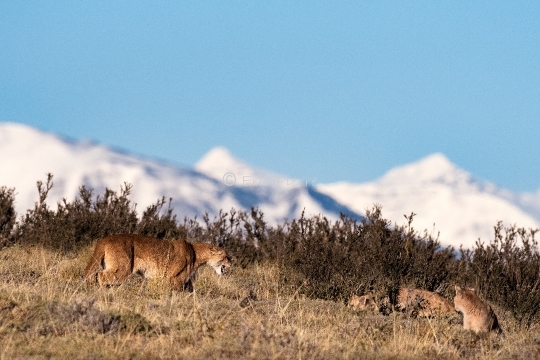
0, 123, 540, 247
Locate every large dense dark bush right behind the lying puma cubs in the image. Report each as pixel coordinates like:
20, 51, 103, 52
268, 206, 457, 303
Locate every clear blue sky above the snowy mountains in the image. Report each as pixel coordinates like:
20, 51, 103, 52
0, 1, 540, 191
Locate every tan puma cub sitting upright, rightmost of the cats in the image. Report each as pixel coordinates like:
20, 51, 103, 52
454, 285, 502, 334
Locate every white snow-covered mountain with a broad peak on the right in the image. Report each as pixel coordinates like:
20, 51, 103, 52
317, 154, 540, 247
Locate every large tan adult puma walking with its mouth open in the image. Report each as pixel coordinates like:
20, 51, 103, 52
85, 234, 231, 291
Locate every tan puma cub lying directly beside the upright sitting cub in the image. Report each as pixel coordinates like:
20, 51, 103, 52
397, 288, 456, 317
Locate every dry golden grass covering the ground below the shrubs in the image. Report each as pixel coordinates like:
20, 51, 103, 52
0, 246, 540, 359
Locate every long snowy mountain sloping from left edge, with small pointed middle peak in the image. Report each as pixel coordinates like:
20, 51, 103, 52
0, 123, 359, 223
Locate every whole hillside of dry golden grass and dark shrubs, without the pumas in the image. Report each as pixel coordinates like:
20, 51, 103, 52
0, 179, 540, 359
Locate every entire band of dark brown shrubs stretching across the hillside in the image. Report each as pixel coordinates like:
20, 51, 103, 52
4, 174, 540, 327
